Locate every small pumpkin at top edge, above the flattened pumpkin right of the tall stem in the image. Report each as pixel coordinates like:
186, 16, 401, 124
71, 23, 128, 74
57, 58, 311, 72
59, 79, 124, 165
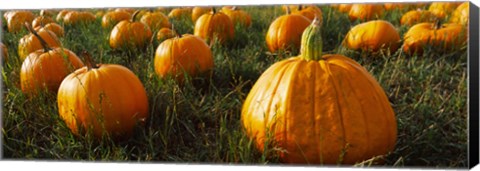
348, 4, 384, 21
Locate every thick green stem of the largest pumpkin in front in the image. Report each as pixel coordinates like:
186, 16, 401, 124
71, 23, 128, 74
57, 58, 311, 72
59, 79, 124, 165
300, 17, 323, 61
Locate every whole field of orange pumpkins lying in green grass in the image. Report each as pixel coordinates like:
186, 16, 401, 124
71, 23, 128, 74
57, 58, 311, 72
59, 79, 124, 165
0, 2, 469, 168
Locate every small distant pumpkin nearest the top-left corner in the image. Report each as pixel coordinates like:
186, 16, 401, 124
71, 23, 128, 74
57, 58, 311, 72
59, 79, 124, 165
5, 11, 35, 33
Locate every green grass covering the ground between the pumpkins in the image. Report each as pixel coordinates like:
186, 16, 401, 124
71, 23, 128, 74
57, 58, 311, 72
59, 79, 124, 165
2, 6, 468, 167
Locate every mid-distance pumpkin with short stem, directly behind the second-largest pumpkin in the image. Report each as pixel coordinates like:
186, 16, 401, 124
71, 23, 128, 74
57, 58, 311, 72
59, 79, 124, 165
109, 11, 152, 49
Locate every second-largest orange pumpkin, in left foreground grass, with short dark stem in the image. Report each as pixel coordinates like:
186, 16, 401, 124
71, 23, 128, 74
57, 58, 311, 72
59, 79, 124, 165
57, 51, 149, 140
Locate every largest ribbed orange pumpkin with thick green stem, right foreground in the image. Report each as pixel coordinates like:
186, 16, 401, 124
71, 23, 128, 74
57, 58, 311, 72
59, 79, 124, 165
241, 18, 397, 164
